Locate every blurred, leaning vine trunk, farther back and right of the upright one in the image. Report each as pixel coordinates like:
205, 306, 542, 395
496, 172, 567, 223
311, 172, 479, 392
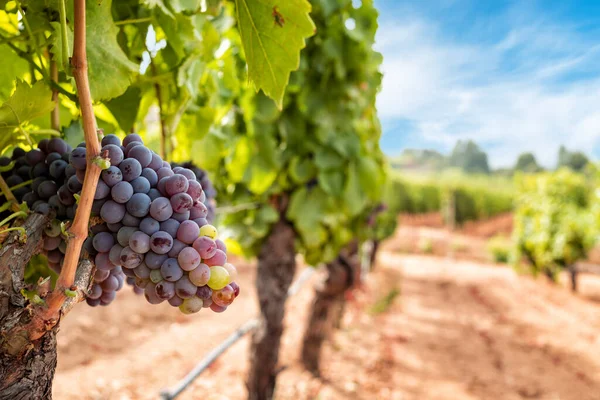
301, 243, 360, 375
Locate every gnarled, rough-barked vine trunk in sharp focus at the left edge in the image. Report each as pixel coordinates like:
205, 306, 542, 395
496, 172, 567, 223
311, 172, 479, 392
0, 214, 57, 400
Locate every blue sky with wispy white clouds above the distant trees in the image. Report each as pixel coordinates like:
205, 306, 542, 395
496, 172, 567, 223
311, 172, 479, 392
375, 0, 600, 167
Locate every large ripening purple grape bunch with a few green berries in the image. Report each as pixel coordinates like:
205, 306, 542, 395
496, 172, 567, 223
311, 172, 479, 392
86, 134, 239, 314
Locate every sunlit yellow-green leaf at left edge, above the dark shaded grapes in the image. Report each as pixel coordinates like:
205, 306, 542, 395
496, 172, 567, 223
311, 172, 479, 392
0, 80, 54, 138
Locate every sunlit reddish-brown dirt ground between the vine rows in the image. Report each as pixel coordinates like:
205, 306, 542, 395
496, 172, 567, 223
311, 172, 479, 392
54, 219, 600, 400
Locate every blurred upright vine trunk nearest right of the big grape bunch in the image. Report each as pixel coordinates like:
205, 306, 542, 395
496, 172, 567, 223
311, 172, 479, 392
247, 216, 296, 400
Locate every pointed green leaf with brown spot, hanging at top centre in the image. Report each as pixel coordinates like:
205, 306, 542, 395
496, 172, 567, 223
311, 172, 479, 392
235, 0, 315, 108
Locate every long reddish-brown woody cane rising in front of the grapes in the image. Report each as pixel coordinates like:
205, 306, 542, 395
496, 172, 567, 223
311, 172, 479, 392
25, 0, 102, 340
